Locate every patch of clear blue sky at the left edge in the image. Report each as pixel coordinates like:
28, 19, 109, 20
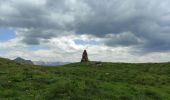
0, 28, 16, 42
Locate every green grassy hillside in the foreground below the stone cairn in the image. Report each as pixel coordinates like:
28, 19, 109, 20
0, 58, 170, 100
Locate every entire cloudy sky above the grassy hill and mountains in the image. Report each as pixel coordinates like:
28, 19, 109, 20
0, 0, 170, 62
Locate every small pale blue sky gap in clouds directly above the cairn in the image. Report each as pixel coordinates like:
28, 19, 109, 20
74, 39, 98, 45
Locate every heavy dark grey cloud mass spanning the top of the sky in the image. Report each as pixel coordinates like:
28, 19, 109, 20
0, 0, 170, 52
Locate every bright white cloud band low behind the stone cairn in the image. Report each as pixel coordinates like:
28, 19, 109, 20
0, 35, 170, 63
